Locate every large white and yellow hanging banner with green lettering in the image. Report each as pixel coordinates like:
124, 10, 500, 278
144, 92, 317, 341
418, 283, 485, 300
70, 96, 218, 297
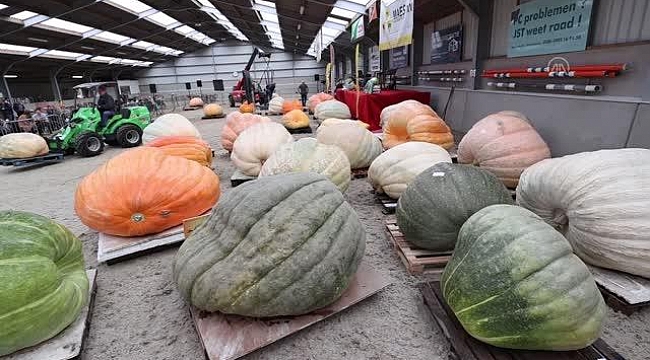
379, 0, 413, 50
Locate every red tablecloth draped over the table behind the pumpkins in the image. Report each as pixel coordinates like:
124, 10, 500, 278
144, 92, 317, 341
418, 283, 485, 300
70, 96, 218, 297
335, 89, 431, 131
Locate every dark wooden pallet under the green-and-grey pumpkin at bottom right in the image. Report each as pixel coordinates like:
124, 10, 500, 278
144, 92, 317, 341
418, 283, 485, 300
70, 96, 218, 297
420, 281, 625, 360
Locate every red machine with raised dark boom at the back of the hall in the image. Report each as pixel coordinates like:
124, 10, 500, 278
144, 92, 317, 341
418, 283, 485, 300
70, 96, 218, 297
228, 48, 275, 107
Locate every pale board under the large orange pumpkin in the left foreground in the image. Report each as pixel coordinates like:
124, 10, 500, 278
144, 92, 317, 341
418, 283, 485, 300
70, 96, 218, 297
97, 225, 185, 265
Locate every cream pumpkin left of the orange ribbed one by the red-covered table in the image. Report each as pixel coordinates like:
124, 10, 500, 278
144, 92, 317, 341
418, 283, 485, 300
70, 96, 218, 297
316, 124, 383, 169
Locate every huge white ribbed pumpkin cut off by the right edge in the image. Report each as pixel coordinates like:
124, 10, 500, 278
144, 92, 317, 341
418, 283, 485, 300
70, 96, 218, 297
517, 149, 650, 278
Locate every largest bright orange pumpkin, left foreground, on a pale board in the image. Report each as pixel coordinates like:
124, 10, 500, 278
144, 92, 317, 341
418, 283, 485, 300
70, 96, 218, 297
75, 147, 221, 236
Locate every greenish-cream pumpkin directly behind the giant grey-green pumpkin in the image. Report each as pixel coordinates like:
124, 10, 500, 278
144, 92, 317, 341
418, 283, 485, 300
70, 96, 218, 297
259, 138, 351, 192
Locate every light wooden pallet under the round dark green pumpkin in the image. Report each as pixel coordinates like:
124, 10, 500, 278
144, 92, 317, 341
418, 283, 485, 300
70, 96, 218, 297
384, 216, 451, 275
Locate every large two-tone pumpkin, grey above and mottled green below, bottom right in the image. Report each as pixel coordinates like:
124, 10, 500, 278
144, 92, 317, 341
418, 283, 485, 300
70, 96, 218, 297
441, 205, 606, 351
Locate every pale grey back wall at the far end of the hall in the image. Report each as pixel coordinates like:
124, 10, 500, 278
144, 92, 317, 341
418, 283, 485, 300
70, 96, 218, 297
137, 42, 325, 97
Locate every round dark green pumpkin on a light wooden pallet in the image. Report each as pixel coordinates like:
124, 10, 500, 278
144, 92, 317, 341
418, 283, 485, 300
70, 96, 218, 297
396, 163, 513, 251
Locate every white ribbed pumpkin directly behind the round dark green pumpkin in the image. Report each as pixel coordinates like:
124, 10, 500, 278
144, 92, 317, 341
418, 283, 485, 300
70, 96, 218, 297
368, 141, 451, 199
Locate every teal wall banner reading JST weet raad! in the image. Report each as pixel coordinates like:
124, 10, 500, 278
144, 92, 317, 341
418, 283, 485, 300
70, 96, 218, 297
508, 0, 593, 57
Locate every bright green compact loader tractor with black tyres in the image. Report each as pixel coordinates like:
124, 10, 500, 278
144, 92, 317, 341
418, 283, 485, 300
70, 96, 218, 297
46, 82, 151, 157
